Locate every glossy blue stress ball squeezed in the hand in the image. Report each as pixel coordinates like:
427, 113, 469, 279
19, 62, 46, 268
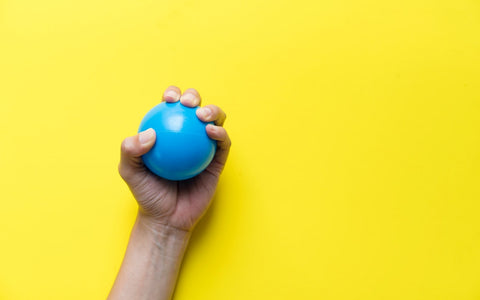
138, 101, 217, 180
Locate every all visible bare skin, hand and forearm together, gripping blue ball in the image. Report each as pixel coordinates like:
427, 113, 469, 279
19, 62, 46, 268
108, 86, 231, 300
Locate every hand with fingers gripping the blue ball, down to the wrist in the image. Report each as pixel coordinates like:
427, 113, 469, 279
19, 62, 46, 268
119, 86, 231, 232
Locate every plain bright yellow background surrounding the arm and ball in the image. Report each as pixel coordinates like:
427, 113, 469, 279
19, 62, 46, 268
0, 0, 480, 300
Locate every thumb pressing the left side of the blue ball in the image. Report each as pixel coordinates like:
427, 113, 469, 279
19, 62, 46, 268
118, 128, 156, 181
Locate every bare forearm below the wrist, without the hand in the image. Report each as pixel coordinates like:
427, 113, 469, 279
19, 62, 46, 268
108, 213, 190, 300
